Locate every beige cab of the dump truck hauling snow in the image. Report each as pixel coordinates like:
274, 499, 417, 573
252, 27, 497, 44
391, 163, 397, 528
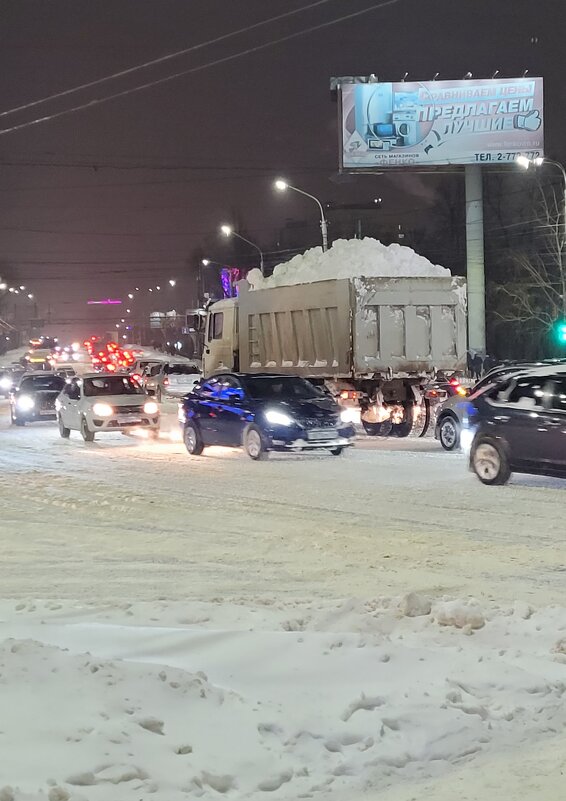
202, 298, 239, 377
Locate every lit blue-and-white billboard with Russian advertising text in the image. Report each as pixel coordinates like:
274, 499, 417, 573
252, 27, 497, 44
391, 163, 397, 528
341, 78, 544, 170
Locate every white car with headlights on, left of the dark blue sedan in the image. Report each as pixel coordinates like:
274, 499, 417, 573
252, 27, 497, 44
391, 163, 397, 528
56, 373, 159, 442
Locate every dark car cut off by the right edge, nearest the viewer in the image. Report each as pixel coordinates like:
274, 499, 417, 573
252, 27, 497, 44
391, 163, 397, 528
465, 366, 566, 484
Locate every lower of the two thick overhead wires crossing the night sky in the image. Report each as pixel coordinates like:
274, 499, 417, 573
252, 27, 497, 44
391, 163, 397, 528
0, 0, 401, 135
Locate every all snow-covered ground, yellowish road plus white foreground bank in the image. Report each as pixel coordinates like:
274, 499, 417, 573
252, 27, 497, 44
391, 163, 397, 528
0, 396, 566, 801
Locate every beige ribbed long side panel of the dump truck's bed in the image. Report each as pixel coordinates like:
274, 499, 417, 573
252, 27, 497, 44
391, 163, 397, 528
238, 279, 351, 377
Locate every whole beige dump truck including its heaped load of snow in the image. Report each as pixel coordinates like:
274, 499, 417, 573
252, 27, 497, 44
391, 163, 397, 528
203, 238, 466, 436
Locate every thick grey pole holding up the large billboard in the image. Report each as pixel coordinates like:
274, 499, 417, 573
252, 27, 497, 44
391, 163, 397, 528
465, 164, 486, 355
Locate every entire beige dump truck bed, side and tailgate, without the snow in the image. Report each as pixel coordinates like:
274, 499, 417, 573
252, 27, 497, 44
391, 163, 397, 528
238, 277, 466, 378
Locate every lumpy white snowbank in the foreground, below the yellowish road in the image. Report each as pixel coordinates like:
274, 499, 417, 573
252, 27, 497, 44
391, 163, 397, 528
0, 593, 566, 801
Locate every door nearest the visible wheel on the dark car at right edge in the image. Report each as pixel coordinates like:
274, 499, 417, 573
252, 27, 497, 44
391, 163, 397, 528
492, 375, 548, 472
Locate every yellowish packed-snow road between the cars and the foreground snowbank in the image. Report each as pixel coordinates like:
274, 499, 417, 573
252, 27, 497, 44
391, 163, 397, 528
0, 407, 566, 604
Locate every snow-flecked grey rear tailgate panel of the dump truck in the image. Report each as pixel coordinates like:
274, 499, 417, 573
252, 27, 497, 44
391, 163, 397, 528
352, 278, 466, 376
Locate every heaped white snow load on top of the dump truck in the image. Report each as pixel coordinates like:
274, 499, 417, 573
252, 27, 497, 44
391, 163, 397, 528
247, 237, 451, 289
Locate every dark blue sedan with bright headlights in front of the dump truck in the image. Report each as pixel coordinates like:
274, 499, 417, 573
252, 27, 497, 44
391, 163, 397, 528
179, 373, 354, 459
